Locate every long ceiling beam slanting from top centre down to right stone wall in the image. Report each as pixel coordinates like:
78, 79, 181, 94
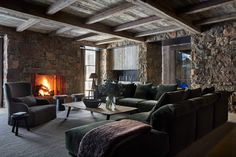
126, 0, 201, 34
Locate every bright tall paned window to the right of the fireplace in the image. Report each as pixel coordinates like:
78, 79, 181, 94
84, 46, 96, 96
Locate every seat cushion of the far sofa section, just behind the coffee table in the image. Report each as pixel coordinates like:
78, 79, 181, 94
116, 98, 146, 107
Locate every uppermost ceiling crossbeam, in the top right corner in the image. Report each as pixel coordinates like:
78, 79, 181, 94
177, 0, 236, 15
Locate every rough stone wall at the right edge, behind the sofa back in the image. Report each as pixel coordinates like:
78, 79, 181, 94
191, 21, 236, 91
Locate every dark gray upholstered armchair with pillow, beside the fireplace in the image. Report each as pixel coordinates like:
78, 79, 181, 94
4, 82, 56, 127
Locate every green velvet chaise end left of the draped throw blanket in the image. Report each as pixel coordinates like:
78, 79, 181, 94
65, 120, 113, 156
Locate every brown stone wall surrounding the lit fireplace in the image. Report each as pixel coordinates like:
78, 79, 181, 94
0, 27, 84, 94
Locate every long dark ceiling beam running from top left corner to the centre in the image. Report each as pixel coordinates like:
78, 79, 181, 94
0, 0, 145, 42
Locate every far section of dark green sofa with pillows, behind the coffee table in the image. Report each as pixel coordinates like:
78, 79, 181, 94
98, 83, 177, 112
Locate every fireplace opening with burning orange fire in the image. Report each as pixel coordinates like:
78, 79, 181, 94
32, 74, 65, 97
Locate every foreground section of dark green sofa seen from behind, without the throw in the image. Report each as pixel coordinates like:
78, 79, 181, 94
65, 88, 229, 157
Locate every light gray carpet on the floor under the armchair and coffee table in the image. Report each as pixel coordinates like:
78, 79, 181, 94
0, 111, 125, 157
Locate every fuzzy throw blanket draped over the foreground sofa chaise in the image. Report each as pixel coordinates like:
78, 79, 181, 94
77, 119, 151, 157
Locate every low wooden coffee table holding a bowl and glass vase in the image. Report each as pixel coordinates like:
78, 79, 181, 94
62, 101, 138, 120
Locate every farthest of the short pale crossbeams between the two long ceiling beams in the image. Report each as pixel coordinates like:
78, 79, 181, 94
136, 26, 182, 37
